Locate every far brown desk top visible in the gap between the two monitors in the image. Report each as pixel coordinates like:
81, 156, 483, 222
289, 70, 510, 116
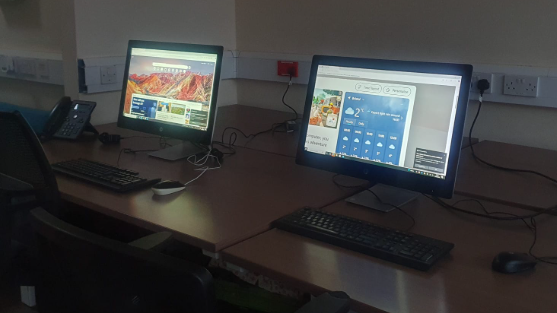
213, 105, 300, 157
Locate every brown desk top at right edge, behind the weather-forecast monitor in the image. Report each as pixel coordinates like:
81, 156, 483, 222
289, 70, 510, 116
455, 141, 557, 210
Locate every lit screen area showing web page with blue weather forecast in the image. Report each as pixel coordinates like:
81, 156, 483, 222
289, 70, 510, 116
305, 65, 462, 179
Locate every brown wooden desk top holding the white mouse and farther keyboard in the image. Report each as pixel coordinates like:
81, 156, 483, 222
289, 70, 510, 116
44, 124, 363, 252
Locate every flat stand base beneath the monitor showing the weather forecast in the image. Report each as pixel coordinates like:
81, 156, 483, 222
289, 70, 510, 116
346, 184, 419, 212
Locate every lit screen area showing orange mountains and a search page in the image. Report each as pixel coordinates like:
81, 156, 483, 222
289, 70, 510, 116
123, 48, 217, 131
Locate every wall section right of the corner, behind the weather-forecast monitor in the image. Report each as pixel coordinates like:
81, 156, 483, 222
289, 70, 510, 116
236, 0, 557, 150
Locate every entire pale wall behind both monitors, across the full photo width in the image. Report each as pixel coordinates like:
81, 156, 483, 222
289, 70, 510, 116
0, 0, 557, 149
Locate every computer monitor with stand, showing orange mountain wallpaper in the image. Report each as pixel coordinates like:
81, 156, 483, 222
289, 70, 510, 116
118, 40, 223, 160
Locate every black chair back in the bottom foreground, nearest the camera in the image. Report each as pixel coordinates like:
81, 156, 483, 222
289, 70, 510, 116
31, 208, 215, 313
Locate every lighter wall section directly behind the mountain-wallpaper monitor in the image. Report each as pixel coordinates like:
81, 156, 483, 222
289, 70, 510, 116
75, 0, 237, 124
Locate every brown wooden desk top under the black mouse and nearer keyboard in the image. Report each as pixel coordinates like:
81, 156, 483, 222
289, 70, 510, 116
223, 196, 557, 313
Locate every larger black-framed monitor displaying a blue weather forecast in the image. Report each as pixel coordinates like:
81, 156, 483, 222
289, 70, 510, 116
296, 56, 472, 204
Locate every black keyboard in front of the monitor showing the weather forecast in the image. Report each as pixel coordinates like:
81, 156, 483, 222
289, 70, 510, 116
275, 208, 454, 271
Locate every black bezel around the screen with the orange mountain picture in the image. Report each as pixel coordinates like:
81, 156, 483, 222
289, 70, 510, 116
118, 40, 224, 145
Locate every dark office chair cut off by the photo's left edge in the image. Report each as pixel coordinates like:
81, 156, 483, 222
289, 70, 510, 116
0, 111, 60, 274
